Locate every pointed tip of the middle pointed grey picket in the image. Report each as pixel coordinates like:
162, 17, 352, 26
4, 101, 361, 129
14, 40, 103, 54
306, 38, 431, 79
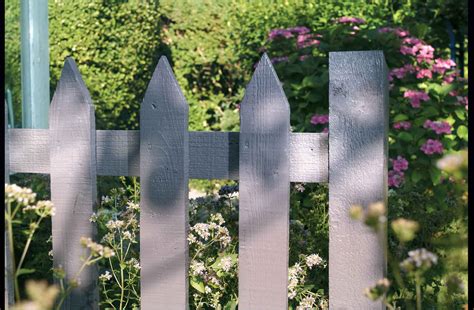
140, 56, 189, 113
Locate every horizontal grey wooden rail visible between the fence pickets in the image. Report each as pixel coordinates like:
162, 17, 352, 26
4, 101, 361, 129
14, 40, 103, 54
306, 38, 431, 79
9, 129, 328, 183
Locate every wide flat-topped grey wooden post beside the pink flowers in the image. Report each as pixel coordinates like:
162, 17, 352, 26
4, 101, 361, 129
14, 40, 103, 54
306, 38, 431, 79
329, 51, 388, 309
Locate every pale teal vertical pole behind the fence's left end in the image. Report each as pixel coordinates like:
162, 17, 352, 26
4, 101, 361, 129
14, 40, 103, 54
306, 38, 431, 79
21, 0, 50, 128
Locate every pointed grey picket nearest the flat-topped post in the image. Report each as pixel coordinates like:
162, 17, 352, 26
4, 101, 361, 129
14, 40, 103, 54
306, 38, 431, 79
239, 55, 290, 309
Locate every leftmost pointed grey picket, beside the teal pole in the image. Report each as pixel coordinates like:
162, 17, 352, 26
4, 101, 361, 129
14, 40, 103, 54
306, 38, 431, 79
49, 58, 98, 309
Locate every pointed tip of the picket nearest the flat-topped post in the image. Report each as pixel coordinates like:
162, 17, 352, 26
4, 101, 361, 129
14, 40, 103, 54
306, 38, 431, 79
240, 53, 290, 132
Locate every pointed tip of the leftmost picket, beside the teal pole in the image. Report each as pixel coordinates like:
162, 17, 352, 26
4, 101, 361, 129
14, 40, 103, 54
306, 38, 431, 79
50, 57, 92, 117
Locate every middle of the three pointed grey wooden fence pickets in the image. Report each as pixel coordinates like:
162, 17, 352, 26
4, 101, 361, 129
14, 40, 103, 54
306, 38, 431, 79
140, 57, 189, 310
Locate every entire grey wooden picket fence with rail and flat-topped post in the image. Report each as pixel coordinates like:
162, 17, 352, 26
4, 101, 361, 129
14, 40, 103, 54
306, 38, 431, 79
5, 51, 388, 310
